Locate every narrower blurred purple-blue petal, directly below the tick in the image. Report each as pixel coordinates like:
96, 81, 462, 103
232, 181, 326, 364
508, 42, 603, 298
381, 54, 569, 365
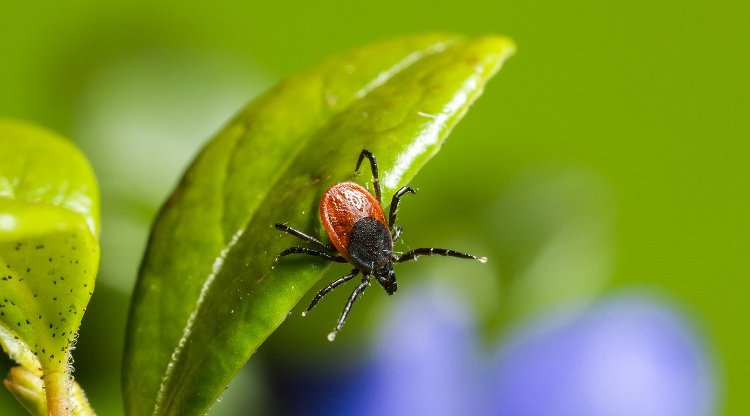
356, 287, 482, 416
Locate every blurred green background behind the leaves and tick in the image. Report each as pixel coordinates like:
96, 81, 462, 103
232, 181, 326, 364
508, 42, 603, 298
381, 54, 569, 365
0, 0, 750, 415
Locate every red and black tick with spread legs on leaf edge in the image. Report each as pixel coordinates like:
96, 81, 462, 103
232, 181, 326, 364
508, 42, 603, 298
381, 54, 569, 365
276, 149, 487, 341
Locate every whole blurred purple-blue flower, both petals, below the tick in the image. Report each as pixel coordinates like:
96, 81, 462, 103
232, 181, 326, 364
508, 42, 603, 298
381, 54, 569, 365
284, 286, 716, 416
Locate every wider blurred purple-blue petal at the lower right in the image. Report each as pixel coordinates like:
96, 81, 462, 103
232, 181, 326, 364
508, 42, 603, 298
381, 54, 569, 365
488, 295, 714, 416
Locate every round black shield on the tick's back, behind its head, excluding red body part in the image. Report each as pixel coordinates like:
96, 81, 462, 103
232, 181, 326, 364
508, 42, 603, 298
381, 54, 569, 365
347, 217, 393, 272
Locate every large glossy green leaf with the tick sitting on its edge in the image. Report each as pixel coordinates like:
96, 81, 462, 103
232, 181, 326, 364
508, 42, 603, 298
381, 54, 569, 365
124, 35, 513, 415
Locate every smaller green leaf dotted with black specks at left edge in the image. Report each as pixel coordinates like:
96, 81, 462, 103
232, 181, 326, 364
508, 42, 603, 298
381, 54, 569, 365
0, 119, 99, 414
